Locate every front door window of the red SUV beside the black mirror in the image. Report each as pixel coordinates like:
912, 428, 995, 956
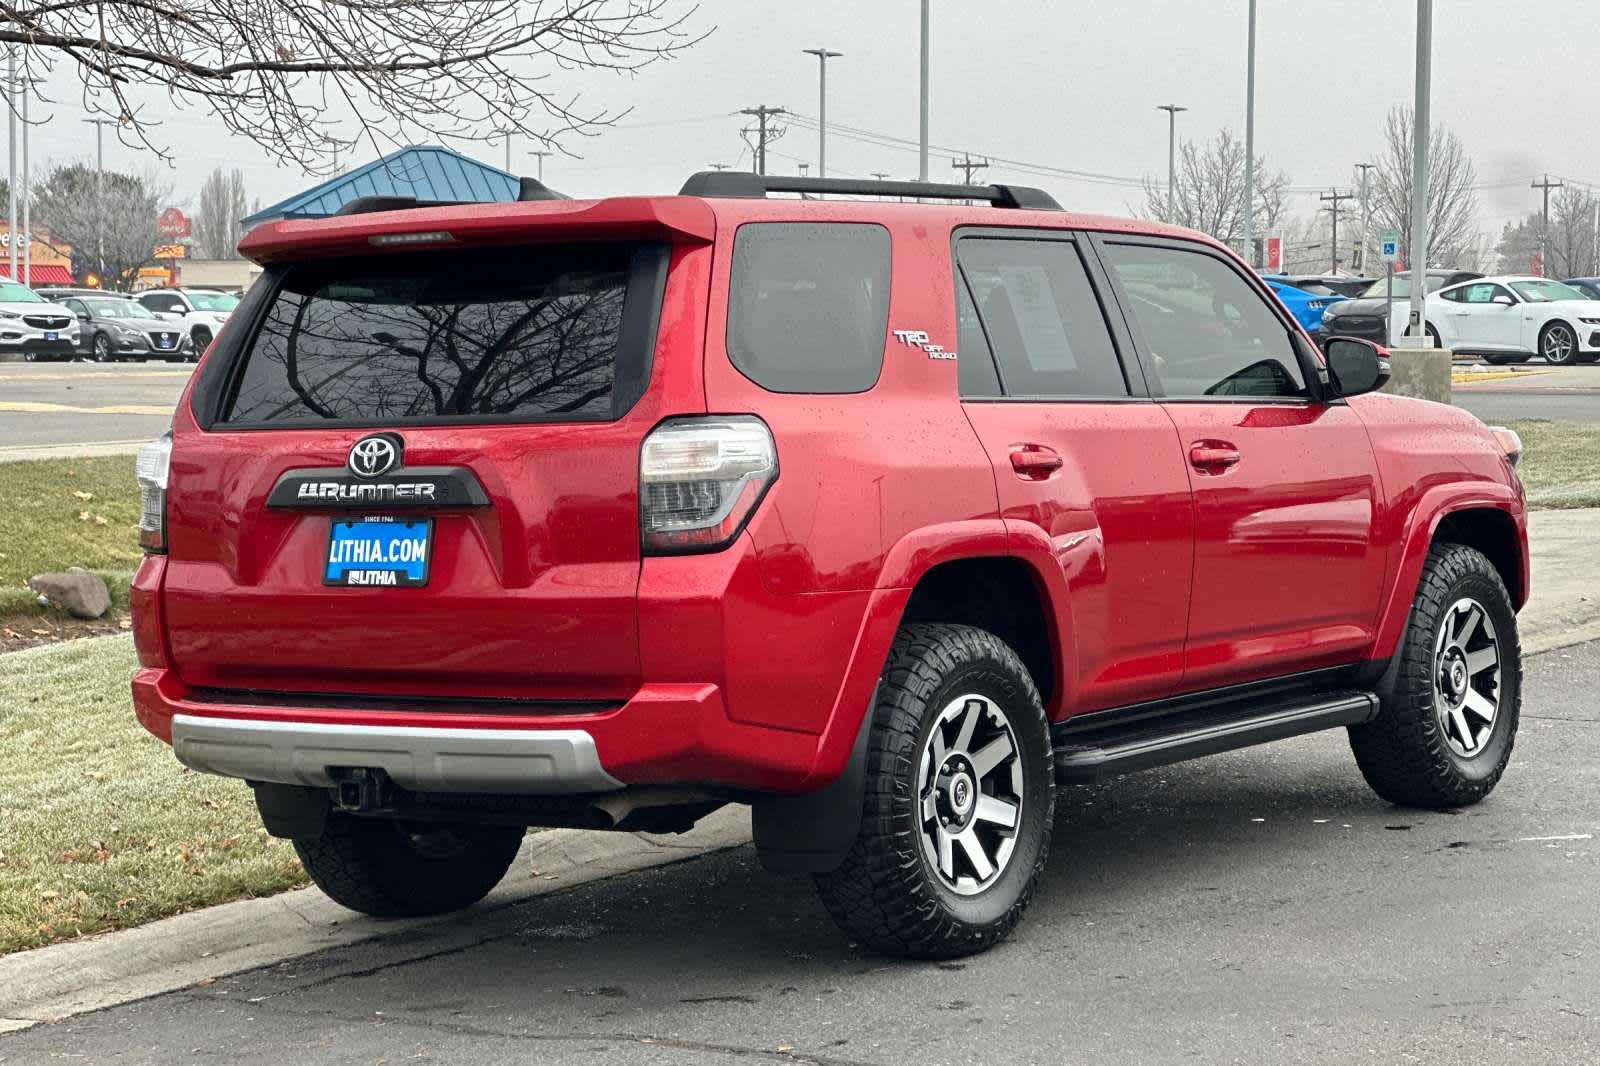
1106, 243, 1307, 399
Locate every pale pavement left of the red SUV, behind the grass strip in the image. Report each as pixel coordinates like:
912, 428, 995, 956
0, 363, 194, 459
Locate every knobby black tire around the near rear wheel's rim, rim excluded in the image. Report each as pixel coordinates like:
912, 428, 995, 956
816, 624, 1056, 959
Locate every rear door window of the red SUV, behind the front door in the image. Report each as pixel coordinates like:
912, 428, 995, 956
957, 237, 1130, 397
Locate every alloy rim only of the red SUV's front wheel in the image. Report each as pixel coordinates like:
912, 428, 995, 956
1434, 597, 1501, 759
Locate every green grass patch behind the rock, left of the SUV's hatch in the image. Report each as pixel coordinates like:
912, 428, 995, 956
0, 455, 139, 615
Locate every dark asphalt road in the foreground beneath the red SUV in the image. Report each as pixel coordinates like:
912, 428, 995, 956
0, 642, 1600, 1066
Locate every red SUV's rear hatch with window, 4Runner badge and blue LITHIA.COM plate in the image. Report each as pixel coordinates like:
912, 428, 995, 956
163, 202, 710, 701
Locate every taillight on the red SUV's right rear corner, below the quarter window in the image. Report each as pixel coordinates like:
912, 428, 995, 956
638, 415, 778, 555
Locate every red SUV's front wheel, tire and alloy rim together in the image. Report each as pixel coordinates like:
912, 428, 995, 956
1350, 544, 1522, 810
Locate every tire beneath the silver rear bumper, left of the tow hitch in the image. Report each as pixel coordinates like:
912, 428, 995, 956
294, 813, 523, 919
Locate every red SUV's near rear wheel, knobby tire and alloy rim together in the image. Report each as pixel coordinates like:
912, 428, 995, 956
816, 626, 1056, 959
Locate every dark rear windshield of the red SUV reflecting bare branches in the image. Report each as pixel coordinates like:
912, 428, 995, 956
222, 243, 666, 426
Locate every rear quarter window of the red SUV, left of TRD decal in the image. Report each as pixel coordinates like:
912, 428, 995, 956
728, 222, 890, 392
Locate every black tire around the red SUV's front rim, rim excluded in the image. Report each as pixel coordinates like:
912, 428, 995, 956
1349, 543, 1522, 810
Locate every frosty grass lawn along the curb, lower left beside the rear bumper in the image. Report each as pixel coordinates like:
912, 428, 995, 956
0, 633, 306, 954
